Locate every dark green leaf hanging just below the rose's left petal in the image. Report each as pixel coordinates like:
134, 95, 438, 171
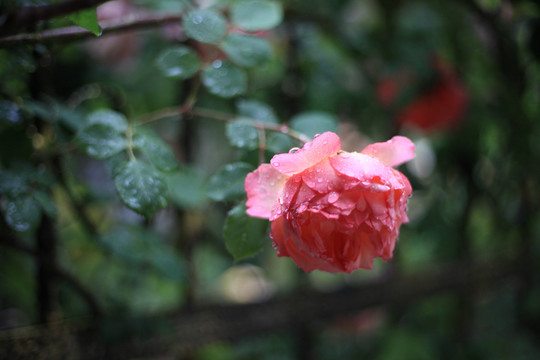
223, 204, 268, 261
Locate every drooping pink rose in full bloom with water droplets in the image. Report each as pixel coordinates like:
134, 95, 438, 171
245, 132, 414, 273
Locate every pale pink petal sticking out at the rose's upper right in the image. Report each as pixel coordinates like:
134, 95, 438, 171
361, 136, 415, 166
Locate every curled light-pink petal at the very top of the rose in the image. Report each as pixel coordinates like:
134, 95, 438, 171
270, 132, 341, 175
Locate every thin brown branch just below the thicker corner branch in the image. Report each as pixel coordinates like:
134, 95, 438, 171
0, 14, 182, 48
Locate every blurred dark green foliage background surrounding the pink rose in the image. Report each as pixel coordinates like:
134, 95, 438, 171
0, 0, 540, 360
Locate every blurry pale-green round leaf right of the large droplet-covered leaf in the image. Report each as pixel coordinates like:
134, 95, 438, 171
166, 169, 206, 209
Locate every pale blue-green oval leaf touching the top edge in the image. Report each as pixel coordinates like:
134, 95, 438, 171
231, 0, 283, 31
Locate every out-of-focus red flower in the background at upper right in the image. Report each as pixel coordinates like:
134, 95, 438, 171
377, 58, 468, 131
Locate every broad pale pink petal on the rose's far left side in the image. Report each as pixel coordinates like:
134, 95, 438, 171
244, 164, 288, 219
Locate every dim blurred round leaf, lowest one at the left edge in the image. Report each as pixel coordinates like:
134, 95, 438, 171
3, 196, 41, 232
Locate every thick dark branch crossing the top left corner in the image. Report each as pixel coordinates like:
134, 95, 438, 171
0, 0, 109, 33
